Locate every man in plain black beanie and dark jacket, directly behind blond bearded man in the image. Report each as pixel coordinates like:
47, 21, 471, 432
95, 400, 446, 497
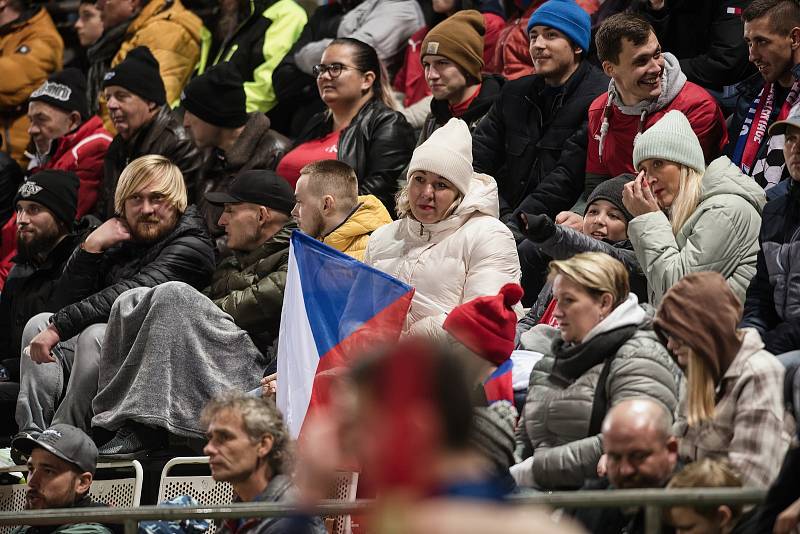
96, 46, 202, 220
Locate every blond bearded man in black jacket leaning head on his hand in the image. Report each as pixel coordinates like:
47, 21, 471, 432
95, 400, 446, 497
12, 155, 214, 452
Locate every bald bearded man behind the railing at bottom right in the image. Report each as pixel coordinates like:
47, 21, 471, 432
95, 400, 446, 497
575, 399, 678, 534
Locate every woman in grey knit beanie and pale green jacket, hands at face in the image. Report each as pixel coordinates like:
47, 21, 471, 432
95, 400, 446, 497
622, 111, 766, 304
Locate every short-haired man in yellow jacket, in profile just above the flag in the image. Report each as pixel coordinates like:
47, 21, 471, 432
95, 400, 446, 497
292, 159, 392, 261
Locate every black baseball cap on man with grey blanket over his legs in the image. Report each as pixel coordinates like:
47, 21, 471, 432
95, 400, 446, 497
206, 170, 295, 215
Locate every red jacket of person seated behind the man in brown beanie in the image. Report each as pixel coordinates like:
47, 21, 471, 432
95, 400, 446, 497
394, 13, 505, 107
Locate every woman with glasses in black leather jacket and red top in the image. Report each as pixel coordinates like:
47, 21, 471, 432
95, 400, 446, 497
277, 38, 415, 213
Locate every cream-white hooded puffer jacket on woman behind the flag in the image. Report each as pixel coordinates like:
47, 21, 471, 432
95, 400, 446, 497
364, 173, 522, 339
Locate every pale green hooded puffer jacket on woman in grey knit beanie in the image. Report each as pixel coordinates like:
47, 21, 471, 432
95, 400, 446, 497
628, 156, 766, 305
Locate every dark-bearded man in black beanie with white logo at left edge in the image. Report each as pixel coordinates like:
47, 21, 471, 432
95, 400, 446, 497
0, 170, 80, 425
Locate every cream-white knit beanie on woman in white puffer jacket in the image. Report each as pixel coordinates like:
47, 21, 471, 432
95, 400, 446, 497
408, 118, 474, 195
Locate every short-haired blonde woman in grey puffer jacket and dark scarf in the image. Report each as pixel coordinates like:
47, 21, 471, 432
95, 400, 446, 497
511, 252, 680, 489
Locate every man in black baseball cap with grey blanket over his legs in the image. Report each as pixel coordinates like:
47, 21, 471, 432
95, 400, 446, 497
92, 170, 297, 459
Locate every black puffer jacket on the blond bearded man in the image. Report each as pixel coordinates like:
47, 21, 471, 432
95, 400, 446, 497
50, 206, 214, 339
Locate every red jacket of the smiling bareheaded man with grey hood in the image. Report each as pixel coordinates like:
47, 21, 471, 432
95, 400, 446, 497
586, 82, 728, 176
